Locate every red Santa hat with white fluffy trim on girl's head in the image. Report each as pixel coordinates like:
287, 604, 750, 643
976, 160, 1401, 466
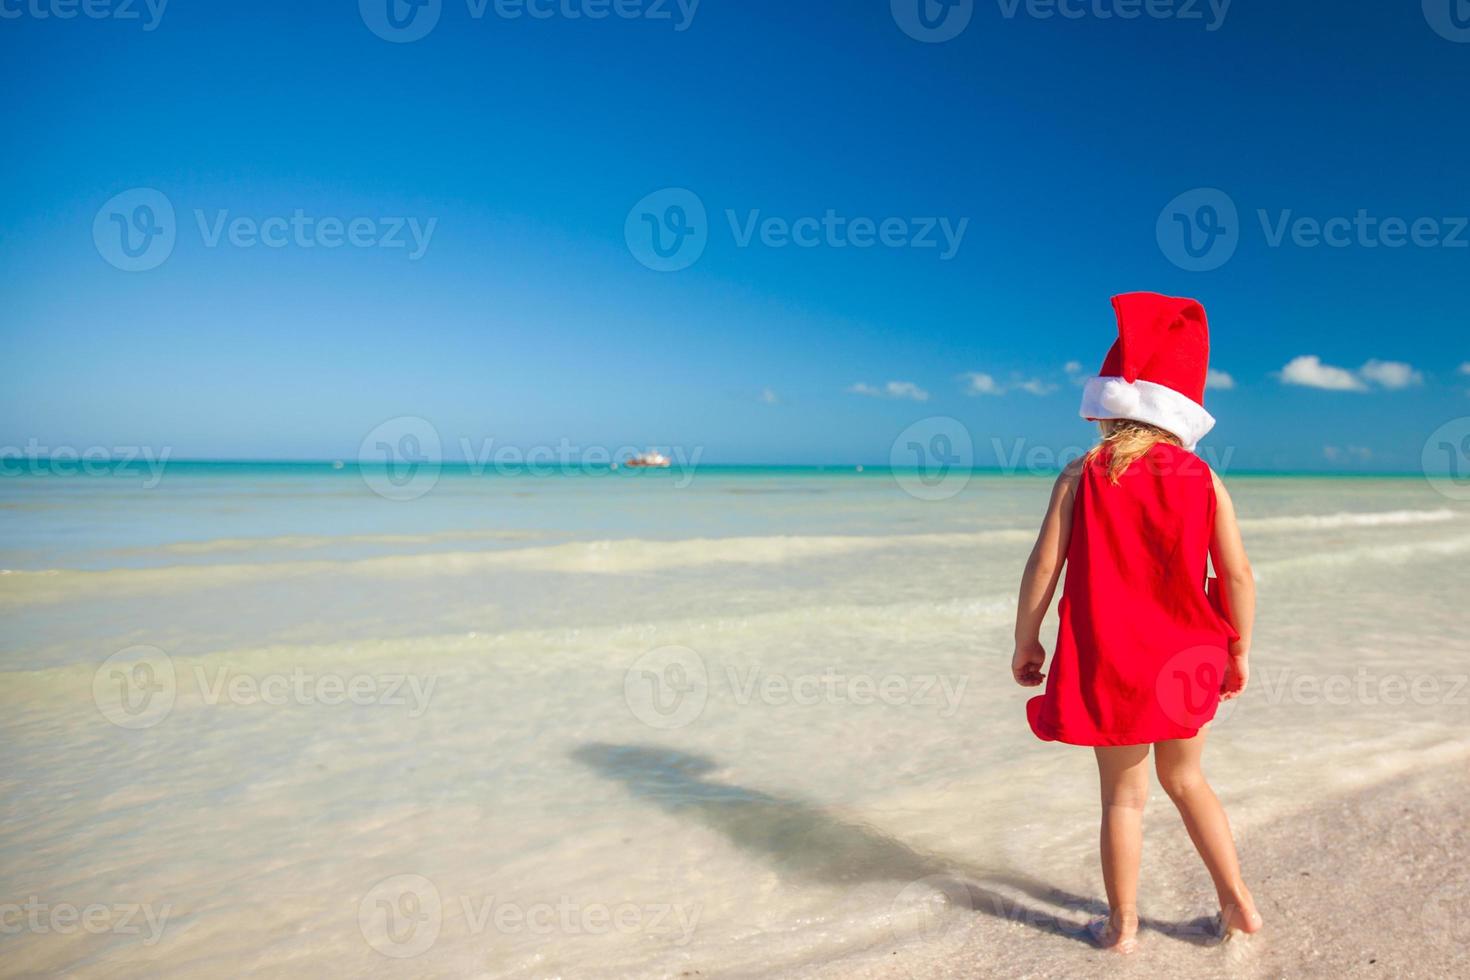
1080, 292, 1214, 451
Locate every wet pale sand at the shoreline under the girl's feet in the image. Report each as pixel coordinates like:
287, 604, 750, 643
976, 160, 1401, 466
798, 765, 1470, 980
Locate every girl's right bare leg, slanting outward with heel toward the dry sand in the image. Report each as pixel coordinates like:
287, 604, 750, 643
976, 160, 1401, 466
1154, 729, 1261, 933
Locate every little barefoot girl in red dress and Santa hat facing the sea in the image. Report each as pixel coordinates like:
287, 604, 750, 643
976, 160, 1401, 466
1011, 292, 1261, 952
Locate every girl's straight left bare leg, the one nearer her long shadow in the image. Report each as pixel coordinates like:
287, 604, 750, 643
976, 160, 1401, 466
1095, 745, 1148, 952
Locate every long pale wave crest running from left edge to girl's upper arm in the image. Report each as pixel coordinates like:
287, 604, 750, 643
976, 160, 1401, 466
0, 529, 1032, 607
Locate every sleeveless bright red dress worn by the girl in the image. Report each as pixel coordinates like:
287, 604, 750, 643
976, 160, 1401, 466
1026, 442, 1236, 745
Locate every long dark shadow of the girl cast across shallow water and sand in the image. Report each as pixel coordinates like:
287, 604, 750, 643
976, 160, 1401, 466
572, 742, 1217, 945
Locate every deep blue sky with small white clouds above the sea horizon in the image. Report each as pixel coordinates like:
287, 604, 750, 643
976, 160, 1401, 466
0, 0, 1470, 470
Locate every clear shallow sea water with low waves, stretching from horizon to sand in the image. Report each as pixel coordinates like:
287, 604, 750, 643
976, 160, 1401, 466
0, 464, 1470, 977
